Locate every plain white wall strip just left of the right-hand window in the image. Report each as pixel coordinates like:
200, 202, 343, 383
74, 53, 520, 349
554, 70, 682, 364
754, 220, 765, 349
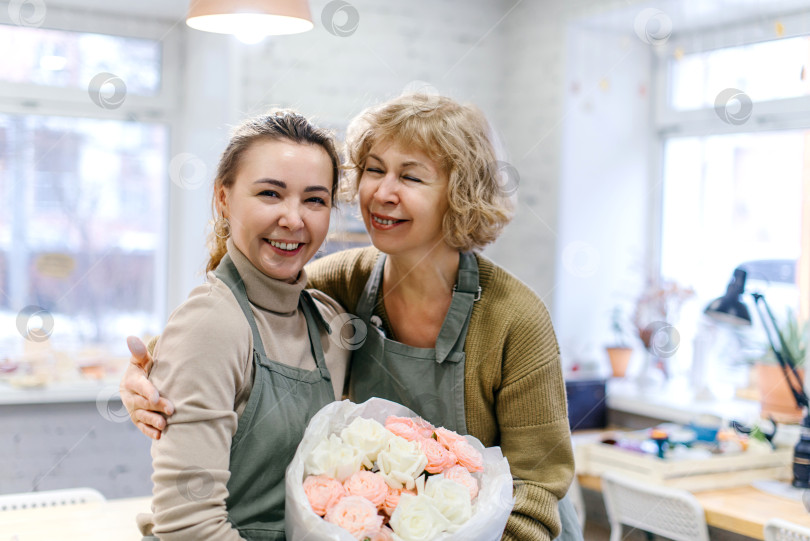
553, 14, 656, 374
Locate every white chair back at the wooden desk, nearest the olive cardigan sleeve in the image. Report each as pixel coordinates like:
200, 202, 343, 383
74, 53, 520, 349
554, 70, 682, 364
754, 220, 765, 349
602, 472, 709, 541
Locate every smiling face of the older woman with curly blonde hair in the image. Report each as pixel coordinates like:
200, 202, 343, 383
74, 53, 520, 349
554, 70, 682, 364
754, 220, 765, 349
358, 141, 448, 254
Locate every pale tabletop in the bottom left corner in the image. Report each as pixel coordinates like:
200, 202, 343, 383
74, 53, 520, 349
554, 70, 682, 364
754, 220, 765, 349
0, 496, 152, 541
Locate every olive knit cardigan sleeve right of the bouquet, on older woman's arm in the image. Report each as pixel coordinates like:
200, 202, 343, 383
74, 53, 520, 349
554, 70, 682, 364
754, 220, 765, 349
495, 296, 574, 541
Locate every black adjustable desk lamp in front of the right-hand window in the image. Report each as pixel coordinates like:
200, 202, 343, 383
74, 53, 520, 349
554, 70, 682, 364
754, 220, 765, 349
704, 262, 810, 488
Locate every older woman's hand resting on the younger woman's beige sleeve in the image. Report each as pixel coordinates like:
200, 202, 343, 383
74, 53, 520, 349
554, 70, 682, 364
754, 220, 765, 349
119, 336, 174, 440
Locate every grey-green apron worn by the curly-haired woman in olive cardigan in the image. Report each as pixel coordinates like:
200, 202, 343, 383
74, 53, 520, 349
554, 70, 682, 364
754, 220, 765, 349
349, 253, 582, 541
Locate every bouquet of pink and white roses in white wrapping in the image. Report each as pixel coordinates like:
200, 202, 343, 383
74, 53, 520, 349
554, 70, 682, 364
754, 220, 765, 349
286, 398, 513, 541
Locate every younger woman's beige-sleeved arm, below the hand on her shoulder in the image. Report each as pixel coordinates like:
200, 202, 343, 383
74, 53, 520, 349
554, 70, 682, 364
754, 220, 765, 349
141, 284, 249, 541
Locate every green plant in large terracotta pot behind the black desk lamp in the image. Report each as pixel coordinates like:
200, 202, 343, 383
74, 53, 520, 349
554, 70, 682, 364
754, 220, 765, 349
754, 310, 810, 423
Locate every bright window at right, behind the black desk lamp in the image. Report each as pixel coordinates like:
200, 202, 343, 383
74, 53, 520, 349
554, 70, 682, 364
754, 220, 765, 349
657, 30, 810, 384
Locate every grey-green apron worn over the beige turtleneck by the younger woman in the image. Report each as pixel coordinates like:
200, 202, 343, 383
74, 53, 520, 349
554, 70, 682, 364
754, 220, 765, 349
215, 255, 335, 541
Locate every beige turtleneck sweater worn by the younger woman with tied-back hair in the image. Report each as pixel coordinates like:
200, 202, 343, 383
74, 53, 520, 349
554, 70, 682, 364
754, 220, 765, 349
138, 240, 350, 541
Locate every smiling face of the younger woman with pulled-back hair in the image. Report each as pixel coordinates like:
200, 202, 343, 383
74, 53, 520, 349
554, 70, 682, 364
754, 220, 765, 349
217, 139, 332, 281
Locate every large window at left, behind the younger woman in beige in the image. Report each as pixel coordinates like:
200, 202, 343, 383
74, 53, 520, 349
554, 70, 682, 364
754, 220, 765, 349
0, 15, 175, 385
